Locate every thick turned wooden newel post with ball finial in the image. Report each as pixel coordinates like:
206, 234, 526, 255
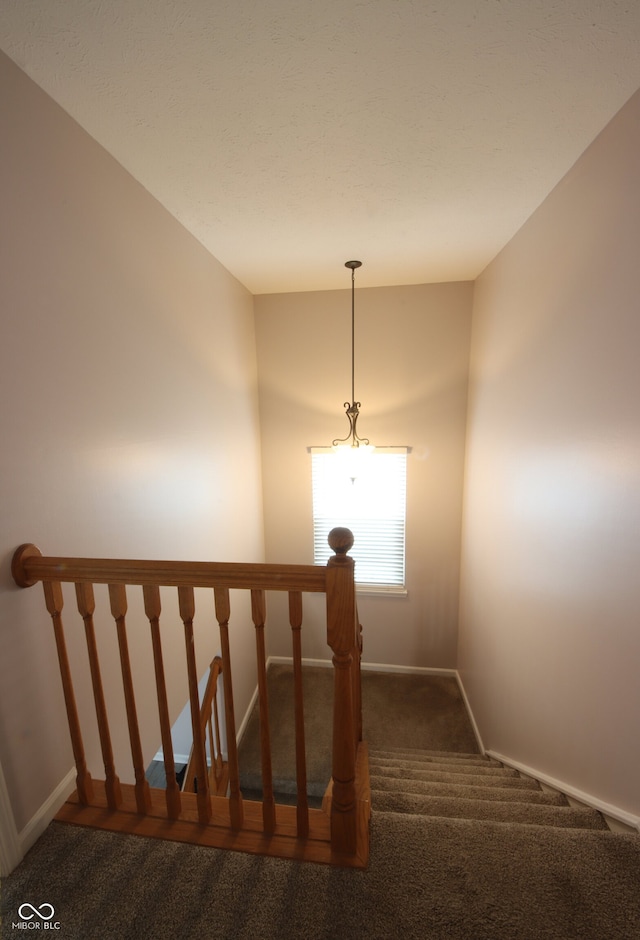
327, 528, 359, 855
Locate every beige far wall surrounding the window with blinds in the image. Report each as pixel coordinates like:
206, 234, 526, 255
255, 280, 472, 667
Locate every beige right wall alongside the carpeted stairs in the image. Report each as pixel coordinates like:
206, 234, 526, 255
459, 93, 640, 814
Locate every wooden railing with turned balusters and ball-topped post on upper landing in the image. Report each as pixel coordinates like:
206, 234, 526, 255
12, 529, 369, 867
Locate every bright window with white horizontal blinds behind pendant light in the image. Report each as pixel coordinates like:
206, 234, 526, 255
311, 447, 407, 590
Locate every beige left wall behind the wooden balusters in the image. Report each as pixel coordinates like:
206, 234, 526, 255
0, 55, 263, 829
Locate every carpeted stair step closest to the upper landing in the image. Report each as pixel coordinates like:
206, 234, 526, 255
371, 788, 607, 829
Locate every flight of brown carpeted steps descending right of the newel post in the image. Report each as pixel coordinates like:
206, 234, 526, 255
369, 748, 607, 830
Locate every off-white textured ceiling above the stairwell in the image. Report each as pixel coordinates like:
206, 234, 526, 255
0, 0, 640, 293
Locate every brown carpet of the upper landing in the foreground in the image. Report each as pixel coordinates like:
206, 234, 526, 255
1, 810, 640, 940
